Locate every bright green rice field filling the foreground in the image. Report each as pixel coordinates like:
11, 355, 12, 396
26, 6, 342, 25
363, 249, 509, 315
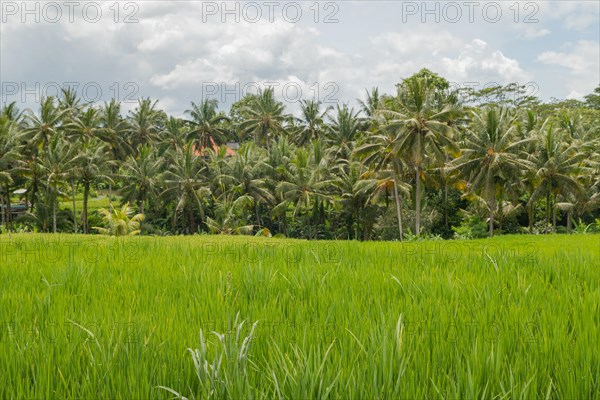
0, 234, 600, 399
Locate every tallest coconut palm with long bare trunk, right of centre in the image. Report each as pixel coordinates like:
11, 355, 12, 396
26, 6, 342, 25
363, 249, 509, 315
379, 77, 461, 235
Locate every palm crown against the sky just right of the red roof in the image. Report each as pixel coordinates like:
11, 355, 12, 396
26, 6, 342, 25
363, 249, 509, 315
238, 88, 288, 147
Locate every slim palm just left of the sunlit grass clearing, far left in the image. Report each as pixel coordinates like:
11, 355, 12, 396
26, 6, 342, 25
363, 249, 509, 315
38, 135, 78, 233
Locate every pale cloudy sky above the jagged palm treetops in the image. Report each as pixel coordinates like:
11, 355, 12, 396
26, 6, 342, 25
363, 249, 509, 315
0, 0, 600, 115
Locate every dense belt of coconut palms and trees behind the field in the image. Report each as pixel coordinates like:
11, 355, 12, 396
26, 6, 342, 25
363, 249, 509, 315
0, 69, 600, 240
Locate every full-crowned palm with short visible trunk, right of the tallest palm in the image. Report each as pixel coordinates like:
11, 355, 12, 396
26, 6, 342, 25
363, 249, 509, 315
453, 107, 532, 236
